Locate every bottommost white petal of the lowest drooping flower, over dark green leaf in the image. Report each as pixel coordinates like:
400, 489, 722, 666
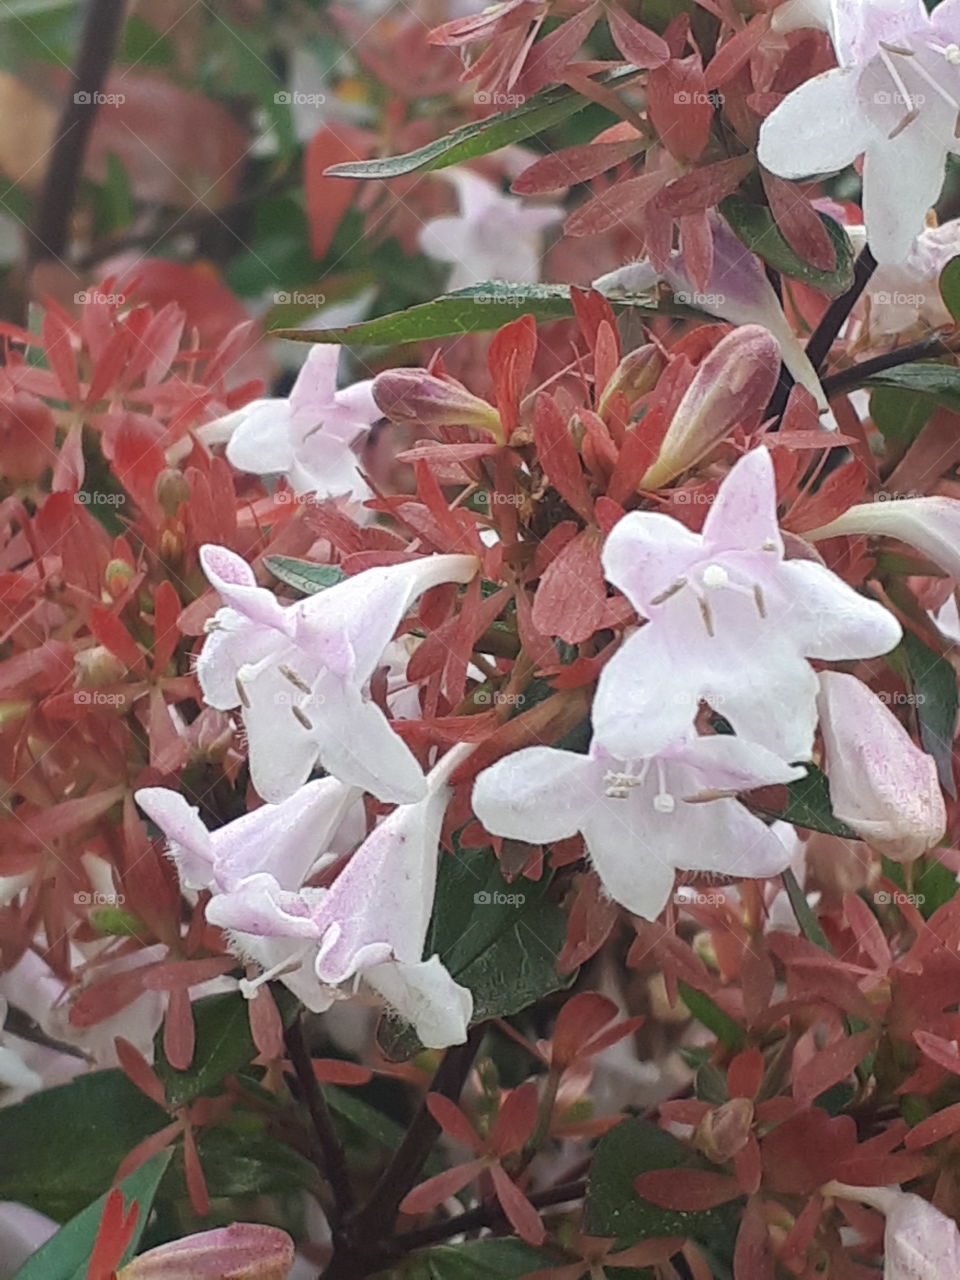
364, 956, 474, 1048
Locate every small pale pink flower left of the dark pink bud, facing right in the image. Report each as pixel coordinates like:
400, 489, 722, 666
197, 343, 383, 498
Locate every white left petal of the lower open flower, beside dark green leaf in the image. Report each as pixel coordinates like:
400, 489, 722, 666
472, 746, 602, 845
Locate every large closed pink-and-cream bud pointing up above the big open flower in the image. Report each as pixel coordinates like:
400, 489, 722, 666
640, 324, 780, 489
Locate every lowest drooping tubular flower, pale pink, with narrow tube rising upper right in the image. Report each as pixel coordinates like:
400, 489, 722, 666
207, 744, 474, 1048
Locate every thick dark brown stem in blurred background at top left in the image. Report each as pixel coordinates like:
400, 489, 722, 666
28, 0, 125, 265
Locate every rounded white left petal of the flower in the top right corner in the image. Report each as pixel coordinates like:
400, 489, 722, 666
758, 67, 870, 180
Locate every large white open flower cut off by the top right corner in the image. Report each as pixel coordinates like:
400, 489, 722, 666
758, 0, 960, 264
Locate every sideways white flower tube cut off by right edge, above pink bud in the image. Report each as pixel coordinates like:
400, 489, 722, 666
804, 495, 960, 582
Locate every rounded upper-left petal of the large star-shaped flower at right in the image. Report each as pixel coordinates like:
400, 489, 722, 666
600, 511, 703, 617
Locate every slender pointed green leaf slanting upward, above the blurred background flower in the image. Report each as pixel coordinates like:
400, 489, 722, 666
326, 67, 637, 178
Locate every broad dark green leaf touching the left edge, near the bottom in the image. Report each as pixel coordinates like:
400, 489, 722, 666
0, 1070, 170, 1222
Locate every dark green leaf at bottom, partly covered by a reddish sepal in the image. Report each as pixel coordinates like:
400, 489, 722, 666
582, 1116, 740, 1252
